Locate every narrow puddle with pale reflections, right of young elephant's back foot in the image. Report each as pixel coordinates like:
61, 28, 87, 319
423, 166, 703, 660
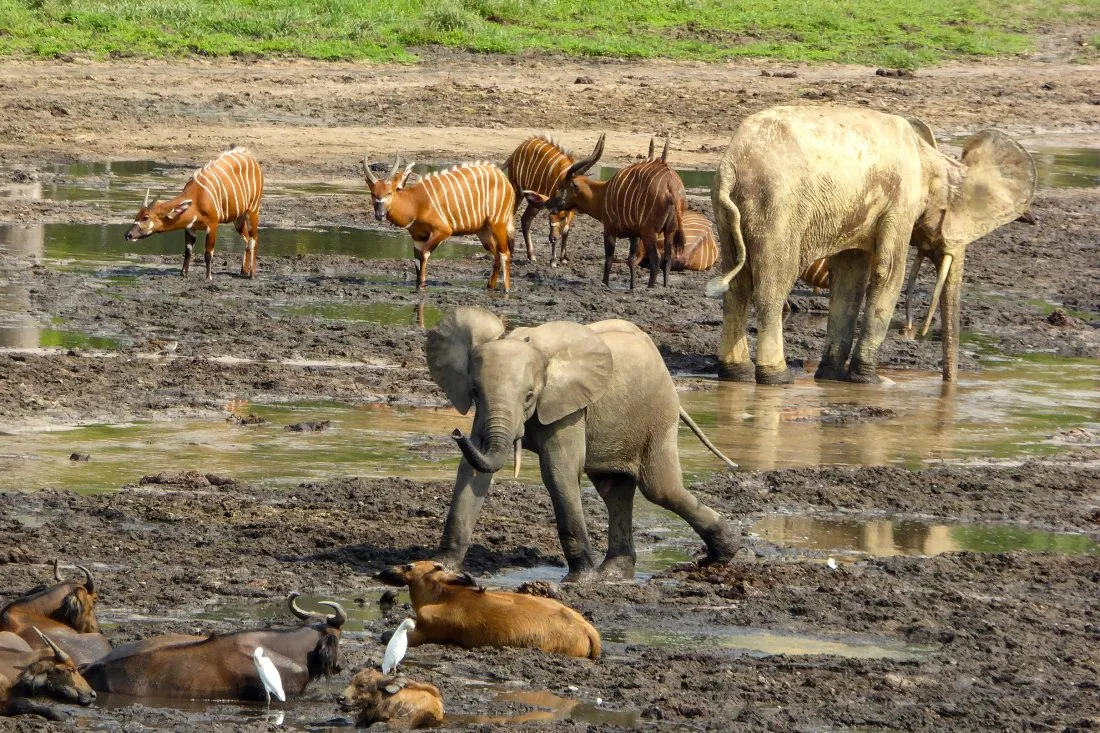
750, 516, 1100, 557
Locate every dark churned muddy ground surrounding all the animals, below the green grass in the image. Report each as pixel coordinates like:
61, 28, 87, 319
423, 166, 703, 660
0, 54, 1100, 731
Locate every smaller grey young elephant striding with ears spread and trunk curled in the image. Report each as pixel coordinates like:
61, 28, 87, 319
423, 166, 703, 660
427, 308, 737, 580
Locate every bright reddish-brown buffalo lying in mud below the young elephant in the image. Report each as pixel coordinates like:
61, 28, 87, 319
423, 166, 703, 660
378, 560, 600, 659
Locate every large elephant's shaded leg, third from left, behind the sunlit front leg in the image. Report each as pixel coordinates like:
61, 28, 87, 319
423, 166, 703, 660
814, 250, 869, 380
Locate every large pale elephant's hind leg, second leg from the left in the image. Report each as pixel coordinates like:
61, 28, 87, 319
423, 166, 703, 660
749, 248, 799, 384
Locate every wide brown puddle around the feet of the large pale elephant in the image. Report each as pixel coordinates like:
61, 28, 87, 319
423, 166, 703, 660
680, 347, 1100, 479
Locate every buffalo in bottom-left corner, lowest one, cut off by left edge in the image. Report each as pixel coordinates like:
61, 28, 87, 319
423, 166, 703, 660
0, 630, 96, 720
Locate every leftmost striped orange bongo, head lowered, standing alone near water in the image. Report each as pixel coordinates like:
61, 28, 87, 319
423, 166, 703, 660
127, 146, 264, 280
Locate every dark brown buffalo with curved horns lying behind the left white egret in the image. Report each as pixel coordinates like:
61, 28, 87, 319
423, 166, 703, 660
84, 593, 348, 701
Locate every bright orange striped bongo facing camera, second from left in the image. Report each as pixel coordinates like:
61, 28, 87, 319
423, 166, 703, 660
363, 156, 516, 293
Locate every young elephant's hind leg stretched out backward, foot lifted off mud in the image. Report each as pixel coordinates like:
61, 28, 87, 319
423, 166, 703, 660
638, 426, 738, 562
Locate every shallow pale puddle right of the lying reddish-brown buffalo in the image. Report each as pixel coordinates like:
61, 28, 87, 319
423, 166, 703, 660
602, 626, 935, 660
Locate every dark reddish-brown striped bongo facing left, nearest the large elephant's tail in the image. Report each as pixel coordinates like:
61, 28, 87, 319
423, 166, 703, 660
547, 133, 685, 289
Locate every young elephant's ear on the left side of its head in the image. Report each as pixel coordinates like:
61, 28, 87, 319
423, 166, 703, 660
425, 307, 504, 415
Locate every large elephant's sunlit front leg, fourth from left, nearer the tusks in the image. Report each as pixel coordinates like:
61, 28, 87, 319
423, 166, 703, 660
848, 221, 912, 384
